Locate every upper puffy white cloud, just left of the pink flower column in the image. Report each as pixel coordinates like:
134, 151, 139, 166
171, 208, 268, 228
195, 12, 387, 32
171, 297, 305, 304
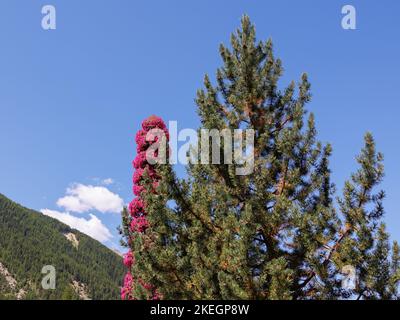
57, 184, 124, 213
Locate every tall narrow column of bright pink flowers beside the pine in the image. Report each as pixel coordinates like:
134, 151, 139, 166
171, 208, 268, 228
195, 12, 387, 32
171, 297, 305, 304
121, 116, 169, 300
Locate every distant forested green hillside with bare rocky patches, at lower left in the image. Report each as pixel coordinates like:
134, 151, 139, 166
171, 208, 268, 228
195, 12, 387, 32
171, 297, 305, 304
0, 194, 125, 300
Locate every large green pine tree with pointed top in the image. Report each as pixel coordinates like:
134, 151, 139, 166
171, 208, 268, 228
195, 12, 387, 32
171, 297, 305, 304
124, 16, 399, 299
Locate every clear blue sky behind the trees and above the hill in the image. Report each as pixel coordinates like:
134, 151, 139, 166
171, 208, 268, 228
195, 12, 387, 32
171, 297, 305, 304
0, 0, 400, 247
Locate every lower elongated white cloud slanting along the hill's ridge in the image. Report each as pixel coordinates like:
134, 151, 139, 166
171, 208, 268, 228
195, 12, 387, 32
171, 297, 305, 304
40, 209, 113, 242
